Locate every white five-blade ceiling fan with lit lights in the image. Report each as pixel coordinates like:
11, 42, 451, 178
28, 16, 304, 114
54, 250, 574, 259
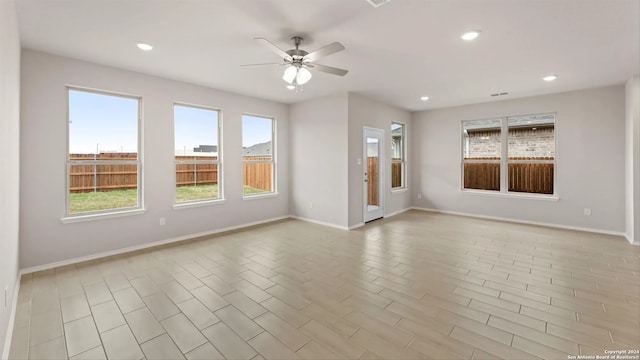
242, 36, 348, 89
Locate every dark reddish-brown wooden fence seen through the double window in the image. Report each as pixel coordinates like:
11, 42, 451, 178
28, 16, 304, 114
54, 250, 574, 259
464, 157, 555, 194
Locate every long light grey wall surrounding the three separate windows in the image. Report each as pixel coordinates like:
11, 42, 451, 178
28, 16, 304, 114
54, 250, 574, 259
20, 50, 289, 268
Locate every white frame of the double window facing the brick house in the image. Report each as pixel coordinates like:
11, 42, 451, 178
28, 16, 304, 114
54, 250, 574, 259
460, 112, 559, 201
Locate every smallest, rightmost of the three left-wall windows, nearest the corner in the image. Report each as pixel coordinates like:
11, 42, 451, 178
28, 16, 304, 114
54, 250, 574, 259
242, 115, 275, 196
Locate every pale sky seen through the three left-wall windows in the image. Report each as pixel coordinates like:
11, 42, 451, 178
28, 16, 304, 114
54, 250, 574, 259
69, 90, 272, 154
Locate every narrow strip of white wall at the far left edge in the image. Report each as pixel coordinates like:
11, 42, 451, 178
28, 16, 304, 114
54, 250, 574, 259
0, 0, 20, 356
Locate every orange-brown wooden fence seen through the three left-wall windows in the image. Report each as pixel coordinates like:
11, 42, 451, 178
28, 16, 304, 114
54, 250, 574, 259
69, 153, 272, 193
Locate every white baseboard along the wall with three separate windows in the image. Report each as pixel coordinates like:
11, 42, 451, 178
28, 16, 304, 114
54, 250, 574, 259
20, 215, 290, 274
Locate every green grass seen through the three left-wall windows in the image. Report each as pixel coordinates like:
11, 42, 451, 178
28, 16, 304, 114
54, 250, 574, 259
69, 184, 267, 214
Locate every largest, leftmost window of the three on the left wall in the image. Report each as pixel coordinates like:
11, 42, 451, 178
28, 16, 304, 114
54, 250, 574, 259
66, 88, 141, 216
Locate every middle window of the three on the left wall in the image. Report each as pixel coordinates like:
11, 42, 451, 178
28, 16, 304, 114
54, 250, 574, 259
173, 105, 222, 203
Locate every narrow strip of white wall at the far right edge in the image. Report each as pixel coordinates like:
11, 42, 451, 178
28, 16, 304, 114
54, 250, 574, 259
625, 75, 640, 245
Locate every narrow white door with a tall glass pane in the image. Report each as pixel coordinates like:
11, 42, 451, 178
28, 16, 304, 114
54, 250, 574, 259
362, 127, 384, 222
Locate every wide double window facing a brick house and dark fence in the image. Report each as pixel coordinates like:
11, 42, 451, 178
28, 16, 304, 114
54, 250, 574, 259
462, 114, 556, 195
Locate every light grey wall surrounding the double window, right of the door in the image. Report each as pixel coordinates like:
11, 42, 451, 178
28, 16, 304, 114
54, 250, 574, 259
412, 86, 625, 234
